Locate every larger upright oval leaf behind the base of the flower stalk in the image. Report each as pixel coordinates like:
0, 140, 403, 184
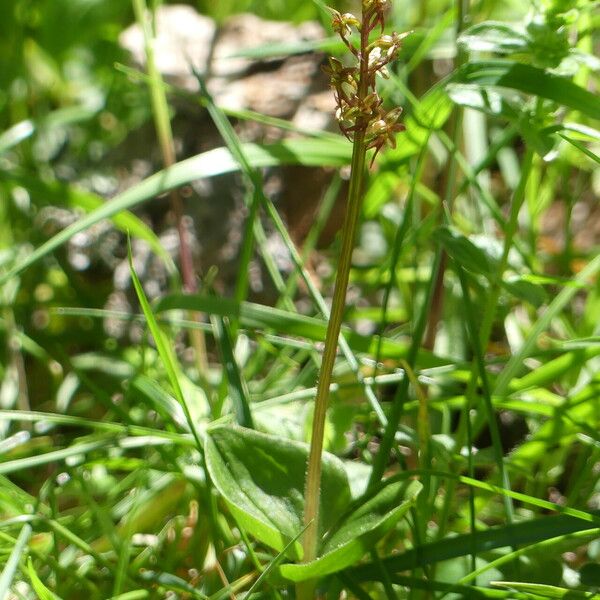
205, 425, 351, 560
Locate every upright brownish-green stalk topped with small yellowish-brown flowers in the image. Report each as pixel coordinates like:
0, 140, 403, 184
298, 0, 407, 598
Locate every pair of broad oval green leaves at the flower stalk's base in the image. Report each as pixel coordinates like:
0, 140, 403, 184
204, 425, 422, 582
